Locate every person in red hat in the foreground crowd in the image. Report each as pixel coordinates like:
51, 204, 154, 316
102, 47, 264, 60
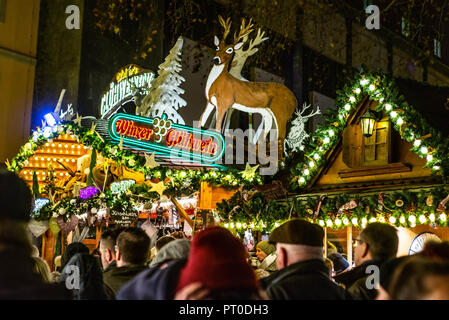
175, 227, 262, 299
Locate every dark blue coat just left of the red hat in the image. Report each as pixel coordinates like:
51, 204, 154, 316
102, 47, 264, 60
117, 260, 187, 300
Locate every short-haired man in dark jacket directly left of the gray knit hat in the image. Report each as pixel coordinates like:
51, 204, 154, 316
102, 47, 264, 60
103, 228, 150, 299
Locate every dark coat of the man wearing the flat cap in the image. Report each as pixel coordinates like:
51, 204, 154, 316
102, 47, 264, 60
260, 259, 350, 300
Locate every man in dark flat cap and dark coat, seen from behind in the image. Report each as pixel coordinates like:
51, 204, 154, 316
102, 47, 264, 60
260, 219, 351, 300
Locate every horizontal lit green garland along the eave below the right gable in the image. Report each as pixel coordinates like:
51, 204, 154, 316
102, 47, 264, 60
217, 187, 449, 231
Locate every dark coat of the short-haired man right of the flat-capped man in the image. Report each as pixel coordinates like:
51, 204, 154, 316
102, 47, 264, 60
334, 259, 383, 300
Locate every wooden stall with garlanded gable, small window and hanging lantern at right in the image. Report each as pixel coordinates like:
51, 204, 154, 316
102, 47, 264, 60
292, 73, 449, 262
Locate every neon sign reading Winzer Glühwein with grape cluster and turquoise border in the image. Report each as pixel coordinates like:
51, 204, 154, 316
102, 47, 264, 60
109, 113, 224, 163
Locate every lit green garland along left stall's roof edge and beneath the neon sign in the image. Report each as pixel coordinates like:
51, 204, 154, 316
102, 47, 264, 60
7, 122, 263, 221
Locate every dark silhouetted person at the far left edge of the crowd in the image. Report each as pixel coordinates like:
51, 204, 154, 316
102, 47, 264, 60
0, 169, 71, 300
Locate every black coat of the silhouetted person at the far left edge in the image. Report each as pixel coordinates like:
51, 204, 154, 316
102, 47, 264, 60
0, 248, 71, 300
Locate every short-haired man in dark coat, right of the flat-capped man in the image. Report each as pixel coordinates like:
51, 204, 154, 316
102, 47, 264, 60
335, 222, 399, 300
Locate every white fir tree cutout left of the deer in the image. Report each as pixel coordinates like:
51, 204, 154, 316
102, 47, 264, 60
137, 37, 187, 124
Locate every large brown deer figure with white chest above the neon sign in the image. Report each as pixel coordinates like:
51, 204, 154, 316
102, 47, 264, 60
200, 17, 298, 143
